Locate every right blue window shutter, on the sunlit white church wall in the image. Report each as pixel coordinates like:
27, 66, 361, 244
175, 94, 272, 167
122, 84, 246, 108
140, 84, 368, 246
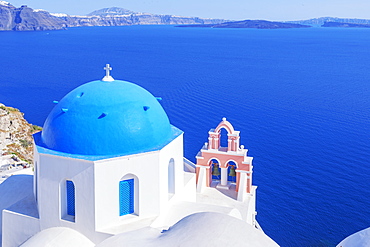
119, 179, 134, 216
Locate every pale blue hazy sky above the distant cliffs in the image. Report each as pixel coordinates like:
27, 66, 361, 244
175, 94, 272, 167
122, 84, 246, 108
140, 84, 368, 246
8, 0, 370, 20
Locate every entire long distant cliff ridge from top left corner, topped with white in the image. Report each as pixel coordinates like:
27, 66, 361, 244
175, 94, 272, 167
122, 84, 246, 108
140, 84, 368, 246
0, 1, 225, 31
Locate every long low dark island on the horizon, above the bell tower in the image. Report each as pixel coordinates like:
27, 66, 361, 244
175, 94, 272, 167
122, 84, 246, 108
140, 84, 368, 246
176, 20, 311, 29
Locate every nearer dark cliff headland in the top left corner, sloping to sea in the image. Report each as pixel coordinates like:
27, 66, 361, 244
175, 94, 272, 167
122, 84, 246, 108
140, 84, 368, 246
0, 1, 66, 31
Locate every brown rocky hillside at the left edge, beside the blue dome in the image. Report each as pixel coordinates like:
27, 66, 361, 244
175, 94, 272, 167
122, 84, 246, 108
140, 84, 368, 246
0, 104, 41, 163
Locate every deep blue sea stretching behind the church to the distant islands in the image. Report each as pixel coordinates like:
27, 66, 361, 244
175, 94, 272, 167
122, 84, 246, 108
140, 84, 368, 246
0, 26, 370, 246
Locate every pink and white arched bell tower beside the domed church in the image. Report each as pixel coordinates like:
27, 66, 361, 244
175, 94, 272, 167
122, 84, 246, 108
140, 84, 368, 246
196, 118, 253, 201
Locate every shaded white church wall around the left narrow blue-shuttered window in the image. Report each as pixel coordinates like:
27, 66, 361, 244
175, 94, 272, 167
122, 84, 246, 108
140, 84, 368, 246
37, 151, 107, 243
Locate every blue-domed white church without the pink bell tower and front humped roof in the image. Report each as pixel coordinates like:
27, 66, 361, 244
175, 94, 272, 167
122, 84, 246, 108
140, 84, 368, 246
2, 65, 266, 247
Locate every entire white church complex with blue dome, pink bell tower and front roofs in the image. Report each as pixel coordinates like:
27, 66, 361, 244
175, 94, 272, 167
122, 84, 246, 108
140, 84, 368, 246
0, 64, 278, 247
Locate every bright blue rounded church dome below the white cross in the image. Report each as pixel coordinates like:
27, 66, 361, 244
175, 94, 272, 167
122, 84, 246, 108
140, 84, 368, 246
41, 76, 172, 155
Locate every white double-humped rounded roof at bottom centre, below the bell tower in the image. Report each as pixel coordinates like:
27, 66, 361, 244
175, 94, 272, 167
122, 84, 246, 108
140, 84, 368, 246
97, 212, 278, 247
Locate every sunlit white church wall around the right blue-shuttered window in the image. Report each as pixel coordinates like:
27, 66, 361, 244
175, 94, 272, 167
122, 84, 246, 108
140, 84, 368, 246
94, 151, 159, 230
